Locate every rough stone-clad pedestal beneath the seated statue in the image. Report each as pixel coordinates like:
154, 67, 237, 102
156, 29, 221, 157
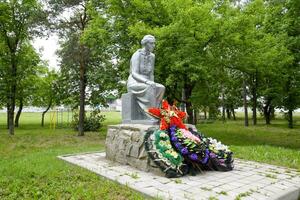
105, 124, 163, 175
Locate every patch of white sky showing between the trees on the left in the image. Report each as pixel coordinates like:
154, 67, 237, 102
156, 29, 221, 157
33, 34, 60, 71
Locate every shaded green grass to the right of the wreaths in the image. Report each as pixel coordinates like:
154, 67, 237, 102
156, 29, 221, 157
197, 117, 300, 171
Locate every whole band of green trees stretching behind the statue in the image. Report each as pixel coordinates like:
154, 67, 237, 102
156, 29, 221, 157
0, 0, 300, 135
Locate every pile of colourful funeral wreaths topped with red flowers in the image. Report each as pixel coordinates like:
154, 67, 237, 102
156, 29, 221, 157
145, 100, 233, 177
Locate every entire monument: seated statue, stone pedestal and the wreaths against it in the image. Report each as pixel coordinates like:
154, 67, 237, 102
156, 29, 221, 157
105, 35, 233, 178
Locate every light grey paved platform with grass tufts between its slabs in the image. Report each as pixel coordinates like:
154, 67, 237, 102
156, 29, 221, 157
59, 153, 300, 200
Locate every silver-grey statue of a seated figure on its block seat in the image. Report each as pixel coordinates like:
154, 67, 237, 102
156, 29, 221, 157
122, 35, 165, 124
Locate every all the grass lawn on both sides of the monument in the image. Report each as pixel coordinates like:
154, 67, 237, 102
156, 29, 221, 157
0, 112, 300, 199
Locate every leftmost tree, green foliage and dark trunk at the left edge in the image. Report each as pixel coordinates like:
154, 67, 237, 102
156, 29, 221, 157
0, 0, 47, 135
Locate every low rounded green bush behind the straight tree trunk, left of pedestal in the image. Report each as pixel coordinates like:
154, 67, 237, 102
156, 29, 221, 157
72, 109, 105, 131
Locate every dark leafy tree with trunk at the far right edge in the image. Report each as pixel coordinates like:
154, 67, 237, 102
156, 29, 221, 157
256, 0, 300, 128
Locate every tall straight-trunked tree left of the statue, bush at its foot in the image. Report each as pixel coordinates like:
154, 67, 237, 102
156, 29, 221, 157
49, 0, 94, 136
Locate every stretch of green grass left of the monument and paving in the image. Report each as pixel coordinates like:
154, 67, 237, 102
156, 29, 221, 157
0, 113, 149, 200
